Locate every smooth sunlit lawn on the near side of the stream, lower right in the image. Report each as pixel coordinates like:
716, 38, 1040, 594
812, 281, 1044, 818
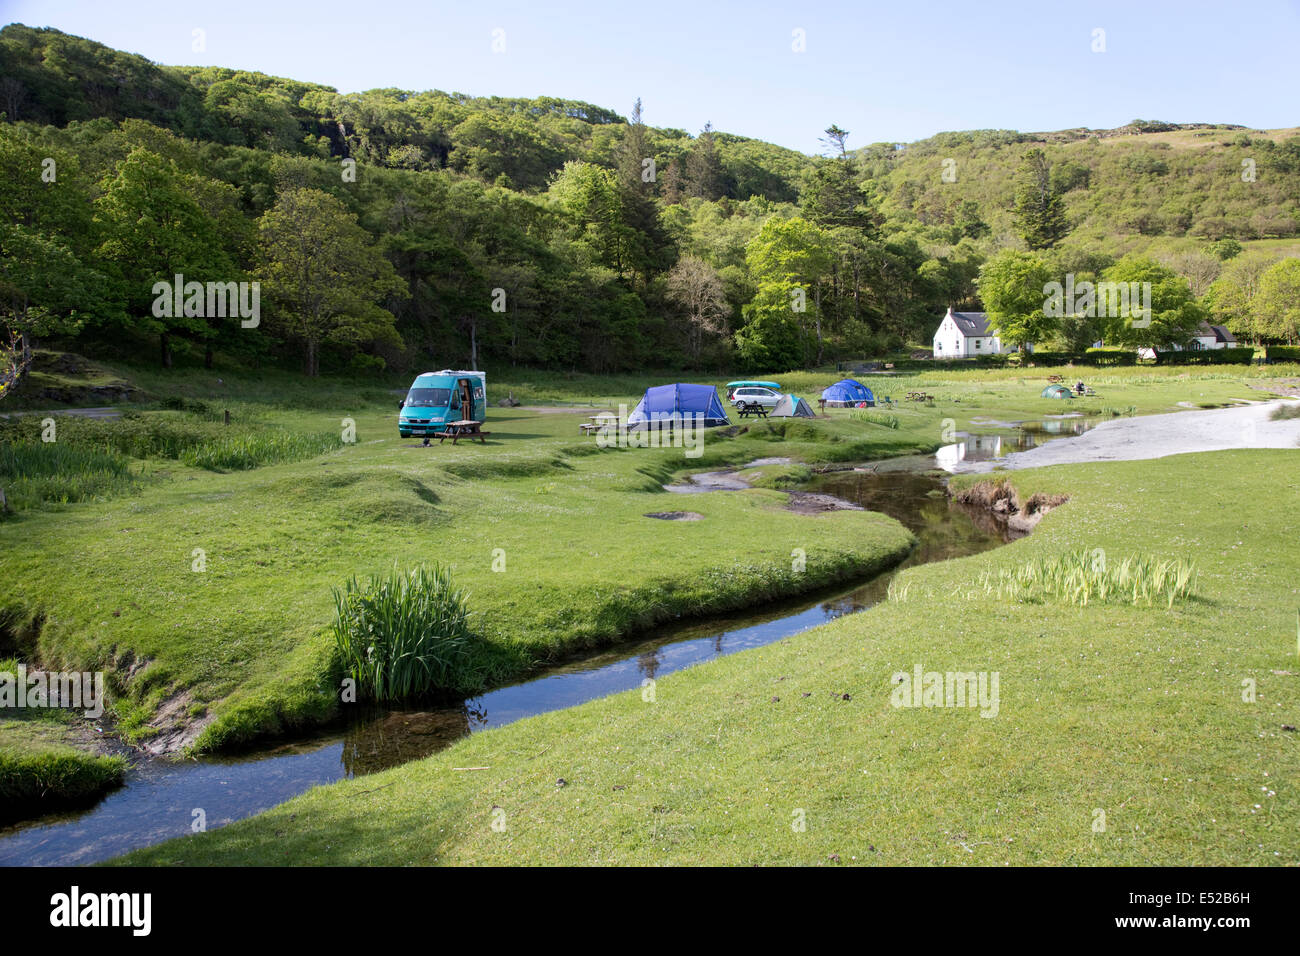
116, 451, 1300, 865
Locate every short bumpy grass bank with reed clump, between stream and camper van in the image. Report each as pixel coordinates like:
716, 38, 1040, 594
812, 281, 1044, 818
0, 390, 915, 749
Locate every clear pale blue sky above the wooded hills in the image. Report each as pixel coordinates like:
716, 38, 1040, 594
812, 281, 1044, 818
0, 0, 1300, 152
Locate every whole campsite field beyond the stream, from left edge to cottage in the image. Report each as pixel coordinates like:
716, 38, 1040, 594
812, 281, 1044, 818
0, 353, 1294, 832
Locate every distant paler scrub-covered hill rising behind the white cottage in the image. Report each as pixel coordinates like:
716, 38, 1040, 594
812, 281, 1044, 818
854, 120, 1300, 247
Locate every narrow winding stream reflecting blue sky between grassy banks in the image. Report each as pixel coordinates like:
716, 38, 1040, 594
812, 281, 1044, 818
0, 423, 1082, 866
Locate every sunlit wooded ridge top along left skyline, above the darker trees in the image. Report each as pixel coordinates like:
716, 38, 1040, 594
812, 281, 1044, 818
0, 23, 811, 202
